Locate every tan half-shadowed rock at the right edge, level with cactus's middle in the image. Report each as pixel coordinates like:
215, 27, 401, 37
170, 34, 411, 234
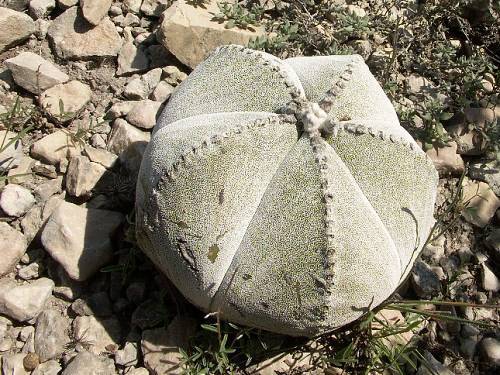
462, 181, 500, 228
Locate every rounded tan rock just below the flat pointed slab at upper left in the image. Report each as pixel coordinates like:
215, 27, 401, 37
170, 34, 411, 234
40, 81, 92, 121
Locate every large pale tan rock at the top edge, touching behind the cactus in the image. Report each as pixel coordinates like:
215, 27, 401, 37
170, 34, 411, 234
158, 0, 265, 68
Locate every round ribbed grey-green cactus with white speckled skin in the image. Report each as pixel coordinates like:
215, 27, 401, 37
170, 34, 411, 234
136, 46, 437, 336
